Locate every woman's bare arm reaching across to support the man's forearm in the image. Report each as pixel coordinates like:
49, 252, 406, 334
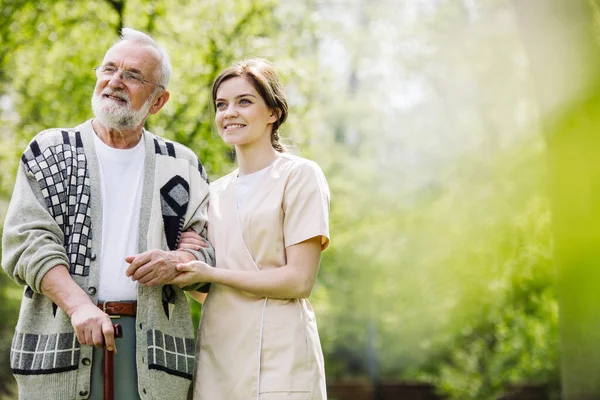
170, 236, 322, 299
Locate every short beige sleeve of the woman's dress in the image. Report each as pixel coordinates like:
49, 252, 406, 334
283, 162, 330, 250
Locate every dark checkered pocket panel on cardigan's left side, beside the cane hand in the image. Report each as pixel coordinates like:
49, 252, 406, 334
10, 332, 81, 375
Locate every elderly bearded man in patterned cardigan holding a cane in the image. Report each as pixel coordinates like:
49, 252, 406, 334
2, 28, 214, 400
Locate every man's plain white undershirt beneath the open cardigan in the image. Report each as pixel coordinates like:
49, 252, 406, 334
94, 135, 145, 301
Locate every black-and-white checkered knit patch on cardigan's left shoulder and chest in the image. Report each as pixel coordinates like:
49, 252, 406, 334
21, 131, 92, 276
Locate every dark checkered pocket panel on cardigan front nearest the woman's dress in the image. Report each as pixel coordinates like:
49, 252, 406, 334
147, 329, 194, 380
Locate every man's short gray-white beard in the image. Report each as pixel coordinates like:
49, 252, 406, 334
92, 93, 154, 131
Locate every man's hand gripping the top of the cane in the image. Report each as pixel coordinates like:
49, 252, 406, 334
70, 302, 117, 353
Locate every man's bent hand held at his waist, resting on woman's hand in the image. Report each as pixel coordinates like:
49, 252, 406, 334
125, 250, 182, 286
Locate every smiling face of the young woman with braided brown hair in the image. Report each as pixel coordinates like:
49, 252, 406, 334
215, 76, 277, 148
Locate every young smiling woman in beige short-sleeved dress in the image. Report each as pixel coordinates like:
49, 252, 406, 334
168, 59, 329, 400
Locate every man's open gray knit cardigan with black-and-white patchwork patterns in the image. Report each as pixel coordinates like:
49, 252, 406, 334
2, 120, 214, 400
